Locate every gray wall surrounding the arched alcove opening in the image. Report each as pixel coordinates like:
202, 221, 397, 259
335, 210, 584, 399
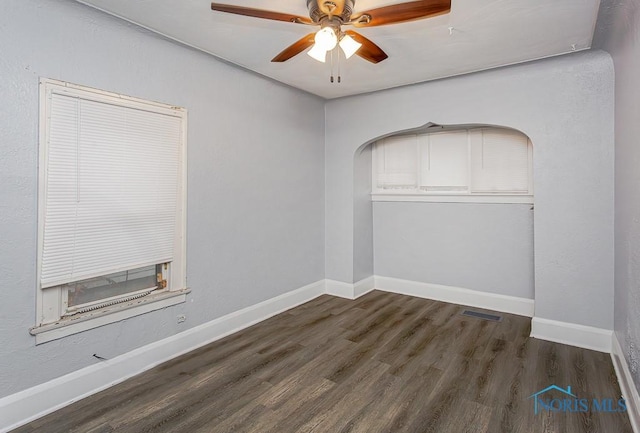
325, 51, 614, 329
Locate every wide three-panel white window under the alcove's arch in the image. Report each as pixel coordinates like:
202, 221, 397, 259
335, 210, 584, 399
372, 128, 533, 203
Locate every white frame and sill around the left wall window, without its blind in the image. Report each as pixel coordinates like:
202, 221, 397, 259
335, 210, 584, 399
30, 78, 190, 344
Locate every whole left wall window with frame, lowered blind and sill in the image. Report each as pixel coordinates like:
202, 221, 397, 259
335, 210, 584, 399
31, 79, 187, 342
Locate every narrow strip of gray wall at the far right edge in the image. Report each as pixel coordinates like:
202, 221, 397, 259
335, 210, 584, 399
596, 0, 640, 389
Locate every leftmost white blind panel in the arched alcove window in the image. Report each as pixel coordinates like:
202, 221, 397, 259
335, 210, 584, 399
376, 135, 418, 189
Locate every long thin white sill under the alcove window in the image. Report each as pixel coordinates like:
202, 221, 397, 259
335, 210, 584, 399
371, 193, 533, 204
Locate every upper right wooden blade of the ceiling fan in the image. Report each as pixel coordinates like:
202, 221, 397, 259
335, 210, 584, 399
351, 0, 451, 27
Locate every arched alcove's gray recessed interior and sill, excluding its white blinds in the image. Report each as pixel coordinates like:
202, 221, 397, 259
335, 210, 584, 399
353, 122, 534, 300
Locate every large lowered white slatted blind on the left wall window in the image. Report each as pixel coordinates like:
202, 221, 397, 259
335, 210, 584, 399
41, 92, 182, 288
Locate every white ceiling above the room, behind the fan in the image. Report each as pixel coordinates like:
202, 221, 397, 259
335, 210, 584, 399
78, 0, 599, 98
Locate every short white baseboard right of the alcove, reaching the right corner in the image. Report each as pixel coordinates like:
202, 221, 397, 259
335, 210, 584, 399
531, 317, 613, 353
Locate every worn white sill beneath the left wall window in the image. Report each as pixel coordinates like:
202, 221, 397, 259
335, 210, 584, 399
29, 288, 191, 345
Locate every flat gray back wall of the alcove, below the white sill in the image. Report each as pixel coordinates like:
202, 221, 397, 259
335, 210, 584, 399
373, 202, 534, 299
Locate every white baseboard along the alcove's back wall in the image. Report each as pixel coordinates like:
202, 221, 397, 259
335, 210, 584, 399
375, 275, 534, 317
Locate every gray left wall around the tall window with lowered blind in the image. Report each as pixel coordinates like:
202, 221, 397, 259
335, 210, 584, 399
0, 0, 324, 397
